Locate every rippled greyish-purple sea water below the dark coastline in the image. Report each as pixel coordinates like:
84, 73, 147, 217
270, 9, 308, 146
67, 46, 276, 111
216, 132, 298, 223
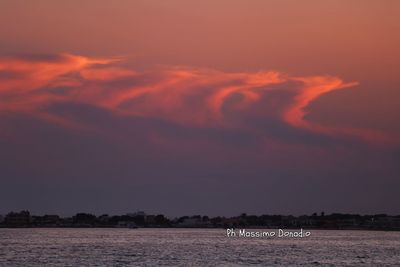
0, 228, 400, 267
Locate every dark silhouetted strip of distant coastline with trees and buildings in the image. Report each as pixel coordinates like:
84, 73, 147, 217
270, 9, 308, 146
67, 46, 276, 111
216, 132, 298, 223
0, 211, 400, 231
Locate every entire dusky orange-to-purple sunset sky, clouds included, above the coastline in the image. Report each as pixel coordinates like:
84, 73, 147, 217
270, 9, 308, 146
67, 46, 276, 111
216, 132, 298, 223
0, 0, 400, 216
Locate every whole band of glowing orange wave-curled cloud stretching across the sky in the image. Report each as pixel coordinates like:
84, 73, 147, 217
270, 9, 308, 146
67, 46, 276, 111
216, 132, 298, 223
0, 54, 398, 142
